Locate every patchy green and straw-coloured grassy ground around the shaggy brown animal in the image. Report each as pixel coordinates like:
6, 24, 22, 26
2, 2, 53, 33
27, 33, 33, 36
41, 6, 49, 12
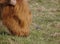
0, 0, 60, 44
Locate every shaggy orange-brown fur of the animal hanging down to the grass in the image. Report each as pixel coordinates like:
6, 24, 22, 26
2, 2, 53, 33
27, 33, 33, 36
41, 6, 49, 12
2, 0, 31, 36
